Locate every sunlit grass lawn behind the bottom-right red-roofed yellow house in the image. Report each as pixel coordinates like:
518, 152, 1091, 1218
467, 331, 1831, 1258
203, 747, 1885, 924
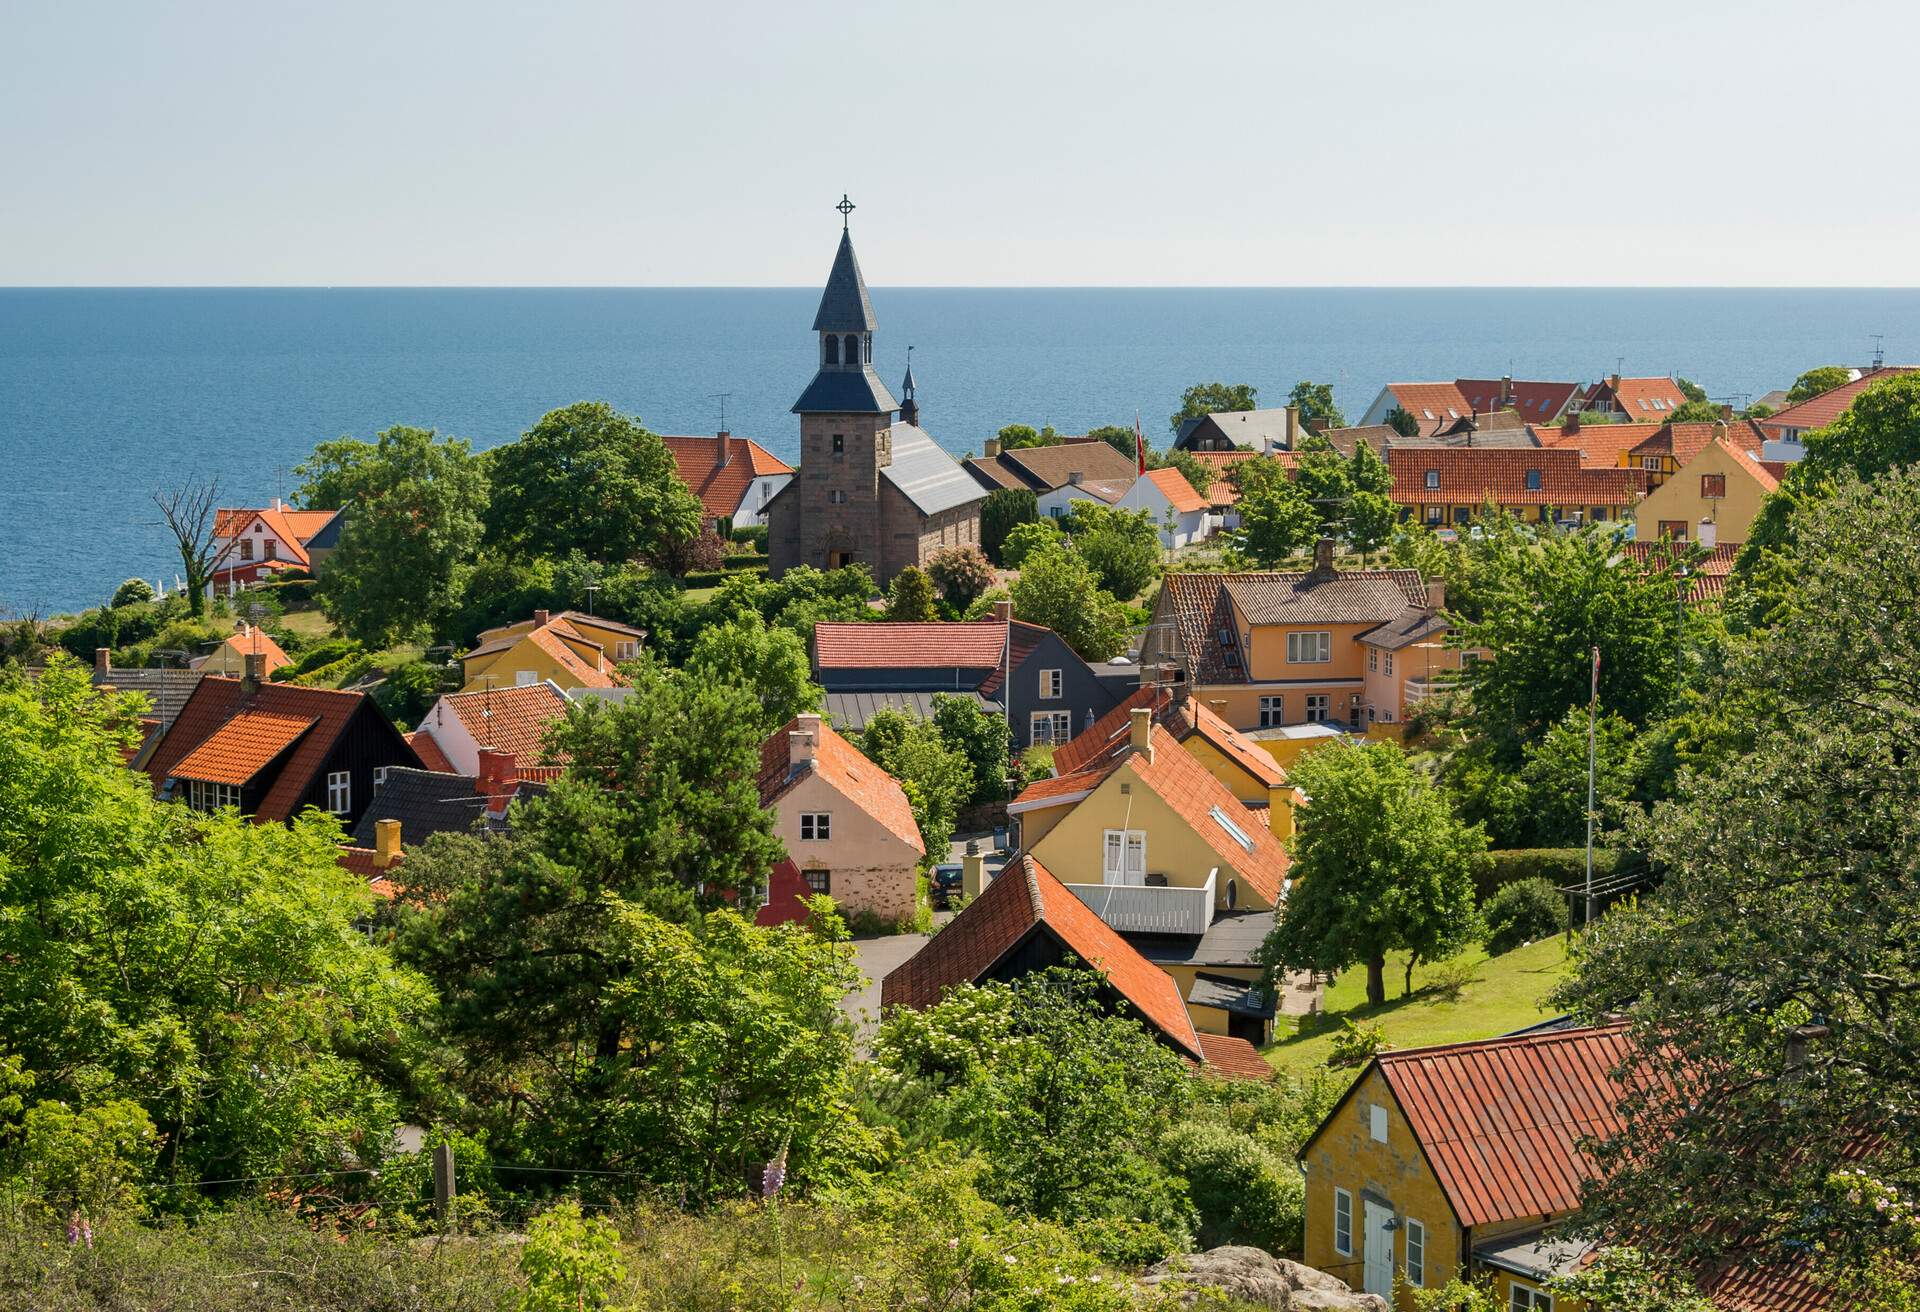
1267, 935, 1567, 1074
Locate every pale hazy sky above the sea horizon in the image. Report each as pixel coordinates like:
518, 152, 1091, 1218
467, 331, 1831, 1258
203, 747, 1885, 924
0, 0, 1920, 286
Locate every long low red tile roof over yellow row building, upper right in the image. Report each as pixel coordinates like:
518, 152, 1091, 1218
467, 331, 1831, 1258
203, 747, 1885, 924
1386, 446, 1647, 507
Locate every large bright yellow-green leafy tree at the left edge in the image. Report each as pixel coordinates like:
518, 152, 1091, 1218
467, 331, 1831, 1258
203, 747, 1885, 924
0, 653, 432, 1206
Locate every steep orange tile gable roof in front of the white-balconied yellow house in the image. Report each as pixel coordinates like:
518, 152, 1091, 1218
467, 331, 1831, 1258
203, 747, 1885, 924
879, 855, 1206, 1060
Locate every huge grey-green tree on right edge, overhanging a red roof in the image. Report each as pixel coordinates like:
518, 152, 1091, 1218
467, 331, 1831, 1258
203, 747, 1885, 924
1557, 469, 1920, 1272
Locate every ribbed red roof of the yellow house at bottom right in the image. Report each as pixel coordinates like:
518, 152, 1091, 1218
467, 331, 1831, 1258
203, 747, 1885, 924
1375, 1026, 1630, 1226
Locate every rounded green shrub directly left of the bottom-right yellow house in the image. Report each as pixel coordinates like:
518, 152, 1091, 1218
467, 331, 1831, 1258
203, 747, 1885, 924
1162, 1122, 1306, 1254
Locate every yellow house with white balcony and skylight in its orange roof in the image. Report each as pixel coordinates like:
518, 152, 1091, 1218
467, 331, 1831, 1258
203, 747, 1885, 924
1008, 705, 1288, 1043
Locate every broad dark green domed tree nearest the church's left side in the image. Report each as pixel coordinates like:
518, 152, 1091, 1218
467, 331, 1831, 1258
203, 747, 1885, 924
486, 401, 703, 563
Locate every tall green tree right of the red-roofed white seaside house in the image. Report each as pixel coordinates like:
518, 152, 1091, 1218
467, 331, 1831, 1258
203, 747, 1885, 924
294, 428, 488, 647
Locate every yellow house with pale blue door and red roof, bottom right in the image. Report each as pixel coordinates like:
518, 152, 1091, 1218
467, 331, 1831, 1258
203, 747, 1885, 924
1300, 1026, 1628, 1312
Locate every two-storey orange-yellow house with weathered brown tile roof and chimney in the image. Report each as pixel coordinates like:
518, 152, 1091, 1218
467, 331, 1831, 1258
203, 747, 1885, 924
1140, 540, 1428, 733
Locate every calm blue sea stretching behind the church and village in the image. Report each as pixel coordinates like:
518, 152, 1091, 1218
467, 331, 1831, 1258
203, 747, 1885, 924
0, 288, 1920, 615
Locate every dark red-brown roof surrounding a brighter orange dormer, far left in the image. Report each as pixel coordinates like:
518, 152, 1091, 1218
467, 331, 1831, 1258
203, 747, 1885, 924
146, 674, 419, 820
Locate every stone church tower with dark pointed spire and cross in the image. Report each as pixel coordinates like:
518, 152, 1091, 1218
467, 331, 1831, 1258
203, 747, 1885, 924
793, 196, 900, 574
